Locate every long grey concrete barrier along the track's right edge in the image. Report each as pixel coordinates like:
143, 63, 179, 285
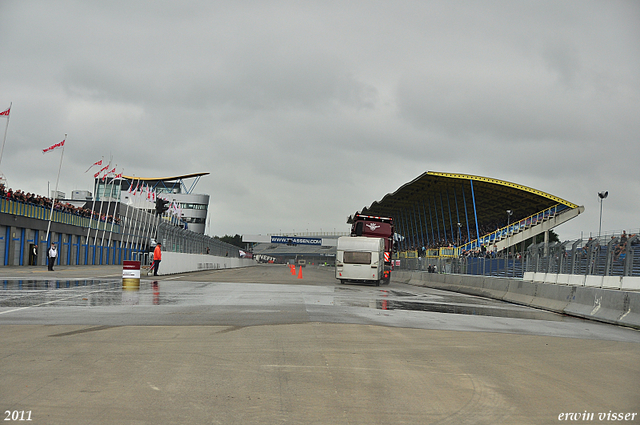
391, 270, 640, 329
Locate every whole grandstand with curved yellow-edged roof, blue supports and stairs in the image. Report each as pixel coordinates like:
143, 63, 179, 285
361, 171, 584, 256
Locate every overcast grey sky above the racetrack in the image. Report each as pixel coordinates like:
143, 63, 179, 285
0, 0, 640, 239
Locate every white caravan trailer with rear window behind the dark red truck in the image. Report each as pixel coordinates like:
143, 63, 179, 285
336, 236, 389, 286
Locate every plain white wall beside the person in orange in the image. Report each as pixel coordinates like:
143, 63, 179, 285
159, 251, 257, 275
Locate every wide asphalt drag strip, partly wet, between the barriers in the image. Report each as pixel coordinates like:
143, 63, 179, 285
0, 265, 640, 424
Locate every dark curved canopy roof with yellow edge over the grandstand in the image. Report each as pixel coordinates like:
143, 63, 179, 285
361, 171, 578, 242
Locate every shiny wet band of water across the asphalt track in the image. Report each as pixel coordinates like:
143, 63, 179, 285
0, 279, 565, 321
